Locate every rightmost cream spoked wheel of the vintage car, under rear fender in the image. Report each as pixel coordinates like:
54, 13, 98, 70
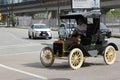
103, 46, 116, 65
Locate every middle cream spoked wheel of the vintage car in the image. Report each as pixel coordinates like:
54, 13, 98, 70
68, 48, 84, 69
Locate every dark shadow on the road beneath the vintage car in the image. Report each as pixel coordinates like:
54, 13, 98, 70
22, 62, 106, 70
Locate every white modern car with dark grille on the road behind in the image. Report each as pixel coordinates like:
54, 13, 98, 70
28, 24, 52, 39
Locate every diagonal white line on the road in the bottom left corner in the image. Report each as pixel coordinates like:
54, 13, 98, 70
0, 64, 48, 80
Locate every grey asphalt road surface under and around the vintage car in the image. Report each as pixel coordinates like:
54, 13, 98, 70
0, 28, 120, 80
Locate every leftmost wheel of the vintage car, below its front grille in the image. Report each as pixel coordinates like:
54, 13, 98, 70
40, 47, 54, 67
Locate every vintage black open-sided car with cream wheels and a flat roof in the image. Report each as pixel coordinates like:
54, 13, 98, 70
40, 12, 118, 69
